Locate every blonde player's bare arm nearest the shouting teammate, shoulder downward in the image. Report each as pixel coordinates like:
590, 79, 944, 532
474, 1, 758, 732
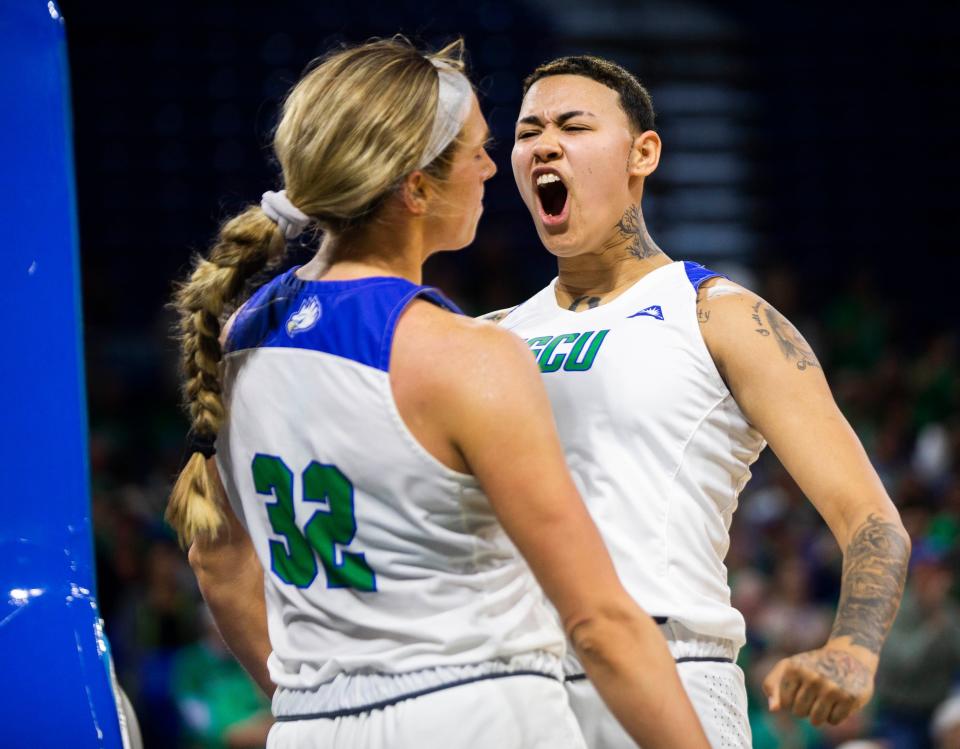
424, 321, 708, 749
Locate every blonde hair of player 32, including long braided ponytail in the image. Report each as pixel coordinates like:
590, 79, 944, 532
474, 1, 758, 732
166, 37, 464, 544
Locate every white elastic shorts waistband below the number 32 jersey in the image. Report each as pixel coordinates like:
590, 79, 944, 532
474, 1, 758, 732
273, 652, 563, 721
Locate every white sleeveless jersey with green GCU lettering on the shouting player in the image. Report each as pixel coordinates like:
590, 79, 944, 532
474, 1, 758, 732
502, 262, 764, 646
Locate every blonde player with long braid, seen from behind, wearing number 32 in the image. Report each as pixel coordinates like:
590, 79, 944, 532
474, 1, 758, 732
168, 40, 707, 749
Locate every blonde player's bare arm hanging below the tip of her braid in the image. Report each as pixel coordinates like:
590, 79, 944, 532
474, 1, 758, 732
189, 459, 276, 697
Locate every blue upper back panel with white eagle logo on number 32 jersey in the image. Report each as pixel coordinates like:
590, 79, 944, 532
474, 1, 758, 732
225, 268, 463, 372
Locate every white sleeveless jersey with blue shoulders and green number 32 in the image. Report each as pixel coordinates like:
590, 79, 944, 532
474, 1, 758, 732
217, 271, 563, 689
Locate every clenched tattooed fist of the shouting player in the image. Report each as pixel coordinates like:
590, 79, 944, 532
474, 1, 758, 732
763, 646, 873, 726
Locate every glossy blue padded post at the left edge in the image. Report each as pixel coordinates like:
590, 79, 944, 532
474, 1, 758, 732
0, 0, 123, 749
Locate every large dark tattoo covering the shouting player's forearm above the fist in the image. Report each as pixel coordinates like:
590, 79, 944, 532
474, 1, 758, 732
830, 515, 910, 655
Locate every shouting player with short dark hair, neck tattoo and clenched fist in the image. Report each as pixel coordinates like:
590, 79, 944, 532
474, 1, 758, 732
489, 57, 909, 749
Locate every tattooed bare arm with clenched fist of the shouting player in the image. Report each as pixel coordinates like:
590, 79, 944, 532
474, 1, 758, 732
697, 280, 910, 724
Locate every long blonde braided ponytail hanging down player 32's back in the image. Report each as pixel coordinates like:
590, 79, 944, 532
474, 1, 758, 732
166, 206, 286, 545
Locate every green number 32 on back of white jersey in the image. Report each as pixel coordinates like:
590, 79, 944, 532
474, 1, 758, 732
252, 454, 377, 591
